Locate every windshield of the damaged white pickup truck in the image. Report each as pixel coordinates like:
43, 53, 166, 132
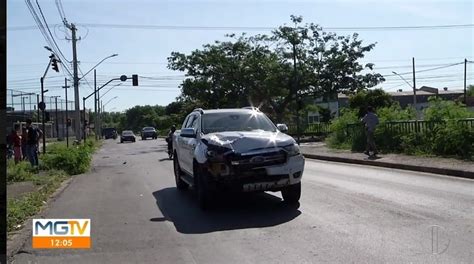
201, 112, 276, 134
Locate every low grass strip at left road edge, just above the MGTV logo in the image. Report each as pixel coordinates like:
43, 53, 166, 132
7, 170, 68, 232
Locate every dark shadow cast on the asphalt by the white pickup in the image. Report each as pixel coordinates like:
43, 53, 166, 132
150, 188, 301, 234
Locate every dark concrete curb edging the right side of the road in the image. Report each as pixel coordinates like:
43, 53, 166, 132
303, 153, 474, 179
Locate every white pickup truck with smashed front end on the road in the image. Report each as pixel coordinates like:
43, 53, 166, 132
173, 107, 305, 209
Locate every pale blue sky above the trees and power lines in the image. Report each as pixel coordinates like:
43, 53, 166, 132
7, 0, 474, 111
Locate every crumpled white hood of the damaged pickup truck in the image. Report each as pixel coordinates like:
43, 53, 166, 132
202, 131, 295, 153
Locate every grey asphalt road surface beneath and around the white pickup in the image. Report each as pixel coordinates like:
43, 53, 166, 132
14, 139, 474, 264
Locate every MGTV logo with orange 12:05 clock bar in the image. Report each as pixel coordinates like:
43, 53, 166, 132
32, 219, 91, 248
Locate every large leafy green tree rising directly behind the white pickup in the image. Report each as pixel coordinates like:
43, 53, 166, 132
168, 16, 384, 122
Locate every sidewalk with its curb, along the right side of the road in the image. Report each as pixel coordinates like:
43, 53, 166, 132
300, 142, 474, 179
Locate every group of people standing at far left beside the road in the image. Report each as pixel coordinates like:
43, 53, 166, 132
7, 119, 43, 167
